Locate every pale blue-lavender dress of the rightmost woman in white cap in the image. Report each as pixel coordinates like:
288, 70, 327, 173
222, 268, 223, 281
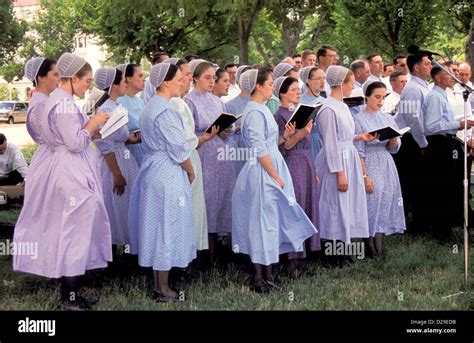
354, 110, 406, 237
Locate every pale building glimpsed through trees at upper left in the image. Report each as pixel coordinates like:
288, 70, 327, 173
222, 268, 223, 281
0, 0, 107, 100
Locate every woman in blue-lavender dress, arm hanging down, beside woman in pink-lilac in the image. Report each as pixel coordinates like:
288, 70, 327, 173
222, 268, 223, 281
94, 68, 138, 262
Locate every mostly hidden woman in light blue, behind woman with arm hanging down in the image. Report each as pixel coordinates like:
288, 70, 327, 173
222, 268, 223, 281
117, 64, 145, 167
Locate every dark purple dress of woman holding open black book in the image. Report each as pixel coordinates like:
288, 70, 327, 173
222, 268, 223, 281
275, 106, 321, 258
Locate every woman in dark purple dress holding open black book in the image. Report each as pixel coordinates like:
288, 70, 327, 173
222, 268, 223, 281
274, 76, 321, 277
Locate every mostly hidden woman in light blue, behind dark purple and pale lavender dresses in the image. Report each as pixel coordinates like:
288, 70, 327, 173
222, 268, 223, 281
300, 66, 326, 159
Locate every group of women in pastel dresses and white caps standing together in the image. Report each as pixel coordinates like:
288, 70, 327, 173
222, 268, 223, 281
13, 46, 470, 309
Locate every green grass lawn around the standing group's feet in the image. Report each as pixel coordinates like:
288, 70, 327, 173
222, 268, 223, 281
0, 222, 474, 310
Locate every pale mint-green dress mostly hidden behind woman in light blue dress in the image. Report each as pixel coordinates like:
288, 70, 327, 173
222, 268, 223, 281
170, 97, 209, 250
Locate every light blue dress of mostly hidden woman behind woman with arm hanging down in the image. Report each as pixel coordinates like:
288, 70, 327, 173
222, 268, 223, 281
117, 95, 145, 167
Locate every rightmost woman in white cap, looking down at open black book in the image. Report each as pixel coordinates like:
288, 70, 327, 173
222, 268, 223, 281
354, 82, 406, 258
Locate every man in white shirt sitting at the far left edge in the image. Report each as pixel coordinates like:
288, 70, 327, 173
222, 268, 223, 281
0, 133, 28, 186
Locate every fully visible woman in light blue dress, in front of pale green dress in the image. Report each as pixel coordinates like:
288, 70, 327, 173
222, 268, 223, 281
129, 63, 196, 301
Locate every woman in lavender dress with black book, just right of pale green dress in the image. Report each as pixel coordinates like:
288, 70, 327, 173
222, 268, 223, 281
184, 60, 236, 262
